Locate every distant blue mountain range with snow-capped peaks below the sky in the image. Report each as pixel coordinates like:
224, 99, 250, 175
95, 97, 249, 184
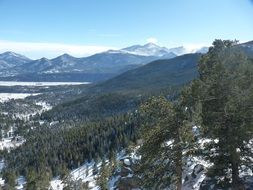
0, 43, 208, 82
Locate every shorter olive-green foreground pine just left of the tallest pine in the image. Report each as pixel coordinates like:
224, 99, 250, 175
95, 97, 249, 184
138, 97, 194, 190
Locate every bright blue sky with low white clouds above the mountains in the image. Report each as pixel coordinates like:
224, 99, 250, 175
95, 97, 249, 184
0, 0, 253, 58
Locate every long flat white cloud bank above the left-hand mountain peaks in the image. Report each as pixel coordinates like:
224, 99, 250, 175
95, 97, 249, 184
0, 40, 115, 59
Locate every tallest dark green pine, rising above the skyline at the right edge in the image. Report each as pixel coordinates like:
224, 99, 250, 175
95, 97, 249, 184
191, 40, 253, 189
